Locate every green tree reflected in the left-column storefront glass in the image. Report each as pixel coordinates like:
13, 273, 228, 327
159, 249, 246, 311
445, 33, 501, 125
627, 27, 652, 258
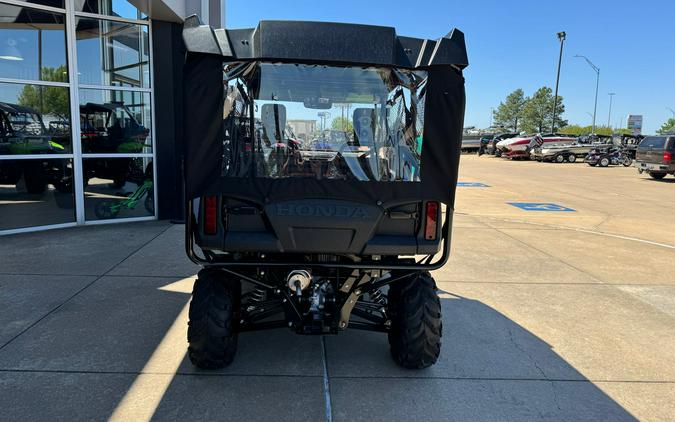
18, 66, 70, 120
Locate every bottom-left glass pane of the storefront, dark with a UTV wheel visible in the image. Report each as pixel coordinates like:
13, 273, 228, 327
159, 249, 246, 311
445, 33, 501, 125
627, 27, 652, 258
0, 158, 75, 230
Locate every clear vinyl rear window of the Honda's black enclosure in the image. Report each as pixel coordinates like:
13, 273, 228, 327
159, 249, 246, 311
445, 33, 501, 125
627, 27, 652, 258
223, 63, 427, 182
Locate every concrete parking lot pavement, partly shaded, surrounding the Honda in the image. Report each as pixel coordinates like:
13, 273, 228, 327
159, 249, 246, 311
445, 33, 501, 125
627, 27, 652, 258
0, 155, 675, 421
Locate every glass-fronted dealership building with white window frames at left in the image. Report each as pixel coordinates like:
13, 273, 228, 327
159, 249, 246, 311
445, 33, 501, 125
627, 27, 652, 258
0, 0, 219, 234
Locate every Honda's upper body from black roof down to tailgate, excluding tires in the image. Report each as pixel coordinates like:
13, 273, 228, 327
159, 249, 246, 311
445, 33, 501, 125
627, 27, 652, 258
185, 21, 466, 266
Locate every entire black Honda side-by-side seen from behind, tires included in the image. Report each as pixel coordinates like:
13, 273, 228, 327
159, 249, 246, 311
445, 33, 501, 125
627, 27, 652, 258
183, 17, 468, 368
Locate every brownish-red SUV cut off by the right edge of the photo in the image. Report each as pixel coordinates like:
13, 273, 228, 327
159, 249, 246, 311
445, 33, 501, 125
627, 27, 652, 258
636, 135, 675, 179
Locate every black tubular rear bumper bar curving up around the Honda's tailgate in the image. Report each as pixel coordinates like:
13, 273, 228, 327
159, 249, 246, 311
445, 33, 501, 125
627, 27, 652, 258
185, 200, 454, 272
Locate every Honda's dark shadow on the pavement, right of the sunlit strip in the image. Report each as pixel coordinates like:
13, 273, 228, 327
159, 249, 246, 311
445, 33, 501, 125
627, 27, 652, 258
140, 292, 635, 421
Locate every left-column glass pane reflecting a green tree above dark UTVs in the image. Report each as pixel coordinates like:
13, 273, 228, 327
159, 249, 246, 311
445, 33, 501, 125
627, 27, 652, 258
0, 83, 72, 155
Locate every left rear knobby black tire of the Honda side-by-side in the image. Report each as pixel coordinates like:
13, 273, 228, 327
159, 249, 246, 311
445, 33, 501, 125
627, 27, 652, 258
188, 270, 241, 369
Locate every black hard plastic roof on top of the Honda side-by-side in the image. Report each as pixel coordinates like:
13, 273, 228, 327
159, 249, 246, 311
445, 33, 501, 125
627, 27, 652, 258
183, 15, 469, 69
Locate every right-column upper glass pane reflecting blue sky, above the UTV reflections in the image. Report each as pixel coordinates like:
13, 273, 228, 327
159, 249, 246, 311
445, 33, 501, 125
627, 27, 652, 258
76, 18, 150, 88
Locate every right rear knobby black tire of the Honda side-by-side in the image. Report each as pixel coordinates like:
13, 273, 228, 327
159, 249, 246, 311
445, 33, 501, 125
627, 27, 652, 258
388, 272, 443, 369
